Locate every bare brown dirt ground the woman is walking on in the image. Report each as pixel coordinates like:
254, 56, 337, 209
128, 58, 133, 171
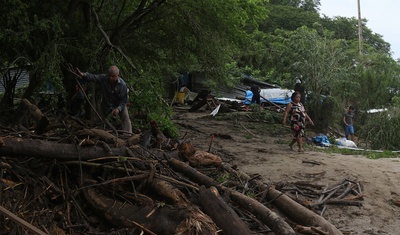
174, 112, 400, 235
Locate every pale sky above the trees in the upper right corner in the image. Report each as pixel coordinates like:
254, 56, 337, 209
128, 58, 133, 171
320, 0, 400, 60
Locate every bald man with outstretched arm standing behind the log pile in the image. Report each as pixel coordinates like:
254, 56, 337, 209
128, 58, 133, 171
77, 65, 132, 133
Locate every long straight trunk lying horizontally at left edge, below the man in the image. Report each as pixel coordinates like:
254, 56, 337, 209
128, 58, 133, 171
0, 138, 131, 160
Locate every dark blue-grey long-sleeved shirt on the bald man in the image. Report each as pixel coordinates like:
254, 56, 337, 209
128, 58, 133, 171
83, 73, 128, 114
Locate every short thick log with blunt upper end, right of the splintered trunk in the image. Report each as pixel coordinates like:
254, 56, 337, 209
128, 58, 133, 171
199, 186, 252, 235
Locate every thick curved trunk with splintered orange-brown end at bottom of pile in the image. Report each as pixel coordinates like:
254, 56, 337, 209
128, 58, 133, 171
83, 184, 217, 235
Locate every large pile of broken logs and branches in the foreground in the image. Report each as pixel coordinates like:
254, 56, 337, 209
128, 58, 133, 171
0, 100, 361, 235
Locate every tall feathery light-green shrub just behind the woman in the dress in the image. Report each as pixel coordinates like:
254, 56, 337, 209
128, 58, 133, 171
268, 27, 349, 129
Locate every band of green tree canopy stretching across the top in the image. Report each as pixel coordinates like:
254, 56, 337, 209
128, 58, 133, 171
0, 0, 399, 149
